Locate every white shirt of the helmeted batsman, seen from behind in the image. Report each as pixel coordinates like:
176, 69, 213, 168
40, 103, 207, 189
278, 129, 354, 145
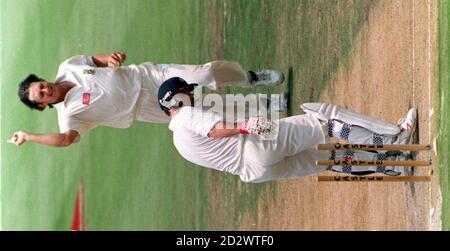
169, 107, 243, 175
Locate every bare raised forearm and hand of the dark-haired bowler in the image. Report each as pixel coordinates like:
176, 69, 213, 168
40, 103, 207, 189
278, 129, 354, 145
8, 130, 79, 147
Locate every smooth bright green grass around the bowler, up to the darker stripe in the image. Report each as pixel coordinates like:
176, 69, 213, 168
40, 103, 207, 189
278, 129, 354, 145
1, 0, 211, 230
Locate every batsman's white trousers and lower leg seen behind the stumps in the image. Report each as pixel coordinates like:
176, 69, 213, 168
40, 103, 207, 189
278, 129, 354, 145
239, 114, 396, 183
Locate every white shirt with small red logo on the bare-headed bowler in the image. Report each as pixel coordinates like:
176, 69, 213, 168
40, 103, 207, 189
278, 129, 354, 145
55, 56, 142, 135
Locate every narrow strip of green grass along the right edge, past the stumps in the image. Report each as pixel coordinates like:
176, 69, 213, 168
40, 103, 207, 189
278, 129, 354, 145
438, 0, 450, 231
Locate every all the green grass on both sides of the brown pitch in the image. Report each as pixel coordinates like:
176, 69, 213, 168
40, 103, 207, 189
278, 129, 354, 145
0, 0, 450, 230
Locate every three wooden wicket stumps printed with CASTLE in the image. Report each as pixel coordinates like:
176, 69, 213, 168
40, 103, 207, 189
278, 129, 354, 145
316, 143, 432, 182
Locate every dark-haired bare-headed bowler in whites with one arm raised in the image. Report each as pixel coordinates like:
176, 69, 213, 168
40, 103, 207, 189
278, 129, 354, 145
9, 52, 284, 146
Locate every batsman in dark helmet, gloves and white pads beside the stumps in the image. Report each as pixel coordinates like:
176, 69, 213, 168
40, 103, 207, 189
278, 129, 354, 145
158, 77, 417, 183
